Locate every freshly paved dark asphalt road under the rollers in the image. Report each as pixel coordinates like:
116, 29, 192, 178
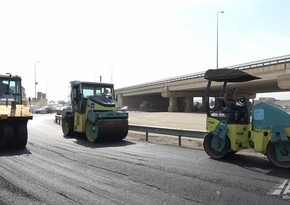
0, 114, 290, 205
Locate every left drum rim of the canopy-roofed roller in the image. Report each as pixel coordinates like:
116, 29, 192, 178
203, 133, 230, 159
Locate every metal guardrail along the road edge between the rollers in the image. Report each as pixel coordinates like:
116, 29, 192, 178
54, 115, 207, 146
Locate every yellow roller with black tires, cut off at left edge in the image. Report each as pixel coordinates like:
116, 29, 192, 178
0, 74, 32, 149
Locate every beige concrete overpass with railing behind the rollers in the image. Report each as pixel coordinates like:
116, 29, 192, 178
115, 55, 290, 112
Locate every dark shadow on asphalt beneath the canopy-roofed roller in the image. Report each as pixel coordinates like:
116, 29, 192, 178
215, 153, 290, 178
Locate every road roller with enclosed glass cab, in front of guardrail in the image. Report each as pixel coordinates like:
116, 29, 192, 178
61, 81, 128, 142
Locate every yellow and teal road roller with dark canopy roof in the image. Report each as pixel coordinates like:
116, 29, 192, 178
203, 69, 290, 168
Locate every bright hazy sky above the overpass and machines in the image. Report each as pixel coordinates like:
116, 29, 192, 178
0, 0, 290, 100
